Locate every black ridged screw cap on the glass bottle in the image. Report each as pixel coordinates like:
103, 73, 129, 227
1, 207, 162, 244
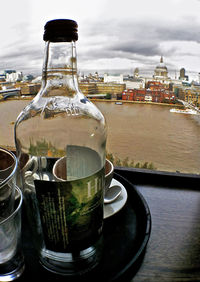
43, 19, 78, 42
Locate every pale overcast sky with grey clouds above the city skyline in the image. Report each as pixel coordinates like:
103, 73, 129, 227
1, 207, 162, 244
0, 0, 200, 79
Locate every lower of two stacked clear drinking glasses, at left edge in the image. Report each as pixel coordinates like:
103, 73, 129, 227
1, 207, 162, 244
0, 186, 24, 281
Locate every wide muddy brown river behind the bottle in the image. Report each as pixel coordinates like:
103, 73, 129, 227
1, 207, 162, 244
0, 100, 200, 174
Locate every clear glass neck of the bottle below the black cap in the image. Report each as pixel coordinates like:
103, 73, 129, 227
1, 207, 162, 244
42, 41, 78, 96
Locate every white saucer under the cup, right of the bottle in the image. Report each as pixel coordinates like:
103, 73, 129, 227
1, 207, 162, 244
104, 178, 128, 219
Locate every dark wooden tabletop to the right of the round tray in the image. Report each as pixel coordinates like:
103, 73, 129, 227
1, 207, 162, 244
129, 184, 200, 282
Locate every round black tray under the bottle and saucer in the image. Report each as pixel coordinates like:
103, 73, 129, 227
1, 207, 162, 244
17, 173, 151, 282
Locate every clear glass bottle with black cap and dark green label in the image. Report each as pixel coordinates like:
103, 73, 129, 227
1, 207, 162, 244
15, 19, 107, 275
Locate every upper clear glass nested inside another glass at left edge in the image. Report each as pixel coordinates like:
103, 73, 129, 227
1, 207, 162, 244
0, 148, 17, 221
